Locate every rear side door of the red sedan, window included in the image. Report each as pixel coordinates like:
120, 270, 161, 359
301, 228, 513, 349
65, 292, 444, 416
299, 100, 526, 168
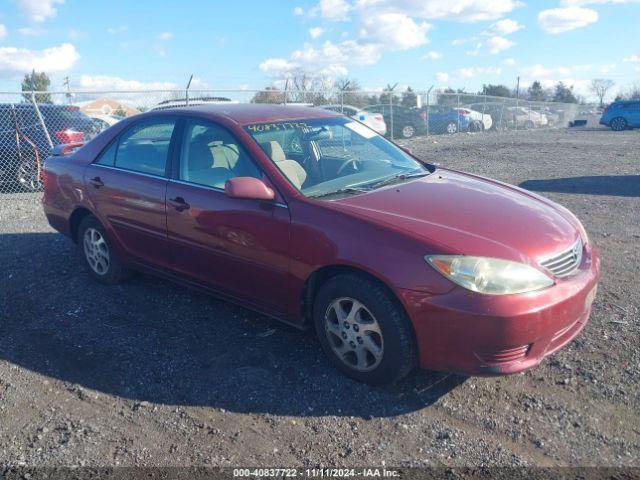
85, 116, 176, 267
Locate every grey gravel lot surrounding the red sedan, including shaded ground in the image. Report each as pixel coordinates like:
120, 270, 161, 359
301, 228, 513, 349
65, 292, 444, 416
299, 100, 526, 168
0, 131, 640, 466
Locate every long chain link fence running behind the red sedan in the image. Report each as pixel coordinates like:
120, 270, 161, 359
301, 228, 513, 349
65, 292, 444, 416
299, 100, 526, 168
0, 88, 584, 195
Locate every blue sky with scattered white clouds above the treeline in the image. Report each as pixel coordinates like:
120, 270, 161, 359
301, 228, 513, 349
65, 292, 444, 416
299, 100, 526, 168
0, 0, 640, 99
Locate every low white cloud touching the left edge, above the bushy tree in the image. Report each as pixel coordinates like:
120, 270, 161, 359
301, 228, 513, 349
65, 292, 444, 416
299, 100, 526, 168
0, 43, 80, 78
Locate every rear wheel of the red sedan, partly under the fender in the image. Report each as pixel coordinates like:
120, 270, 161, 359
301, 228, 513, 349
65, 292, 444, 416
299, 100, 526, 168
77, 215, 131, 285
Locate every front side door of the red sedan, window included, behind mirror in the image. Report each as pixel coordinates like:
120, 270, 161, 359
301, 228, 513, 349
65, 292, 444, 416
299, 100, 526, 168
166, 119, 290, 314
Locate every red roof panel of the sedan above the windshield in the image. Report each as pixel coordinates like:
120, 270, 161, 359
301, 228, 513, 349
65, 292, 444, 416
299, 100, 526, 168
154, 103, 340, 125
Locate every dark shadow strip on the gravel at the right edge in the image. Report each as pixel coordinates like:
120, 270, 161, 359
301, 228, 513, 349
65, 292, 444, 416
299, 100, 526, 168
520, 175, 640, 197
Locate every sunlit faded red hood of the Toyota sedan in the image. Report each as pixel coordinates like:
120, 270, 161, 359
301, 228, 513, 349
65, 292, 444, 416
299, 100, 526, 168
331, 169, 580, 263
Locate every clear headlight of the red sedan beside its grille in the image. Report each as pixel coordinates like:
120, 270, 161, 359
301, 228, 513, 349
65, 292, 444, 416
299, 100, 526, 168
424, 255, 553, 295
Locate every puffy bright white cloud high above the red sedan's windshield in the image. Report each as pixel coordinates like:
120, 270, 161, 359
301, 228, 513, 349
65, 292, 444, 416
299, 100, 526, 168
360, 13, 431, 50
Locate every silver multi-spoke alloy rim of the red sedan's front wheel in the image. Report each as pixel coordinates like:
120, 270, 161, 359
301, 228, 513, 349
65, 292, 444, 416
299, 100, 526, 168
324, 297, 384, 372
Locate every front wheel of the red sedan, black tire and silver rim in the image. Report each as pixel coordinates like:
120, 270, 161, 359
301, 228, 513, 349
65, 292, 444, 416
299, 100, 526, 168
313, 274, 416, 385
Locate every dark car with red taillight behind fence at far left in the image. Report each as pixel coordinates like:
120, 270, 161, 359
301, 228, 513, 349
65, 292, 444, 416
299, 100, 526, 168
0, 103, 98, 191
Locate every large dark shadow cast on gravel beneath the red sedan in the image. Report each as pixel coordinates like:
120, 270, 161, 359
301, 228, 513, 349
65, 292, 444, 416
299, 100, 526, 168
0, 233, 465, 417
